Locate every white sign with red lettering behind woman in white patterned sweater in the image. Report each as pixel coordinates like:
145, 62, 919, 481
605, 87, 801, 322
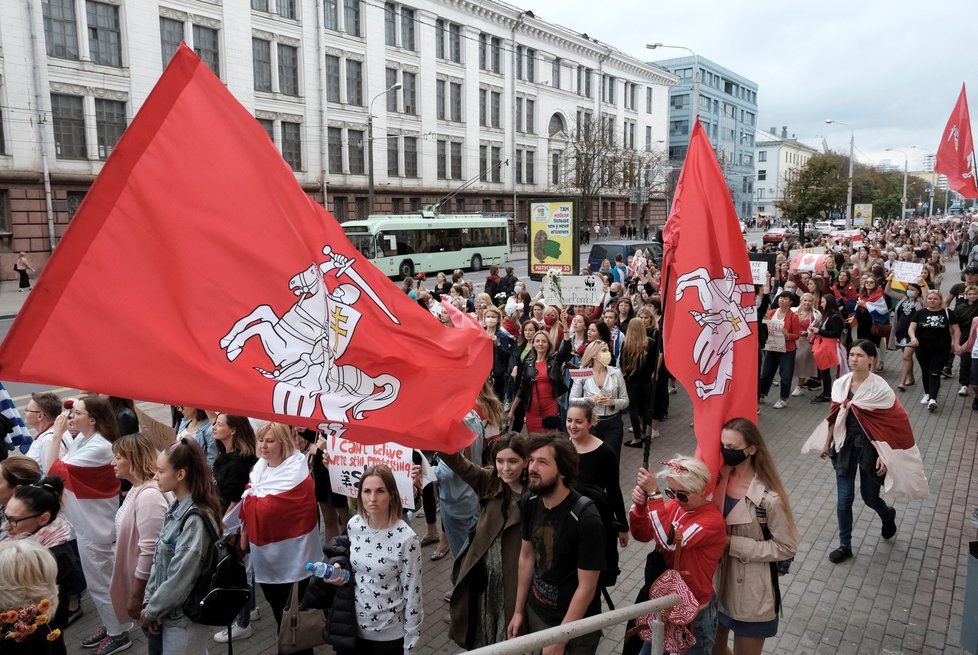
326, 434, 414, 509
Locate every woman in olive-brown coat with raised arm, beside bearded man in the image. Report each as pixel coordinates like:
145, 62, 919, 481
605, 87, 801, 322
439, 432, 527, 650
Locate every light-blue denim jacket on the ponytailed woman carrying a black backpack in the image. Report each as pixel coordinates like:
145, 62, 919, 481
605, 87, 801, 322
143, 496, 217, 621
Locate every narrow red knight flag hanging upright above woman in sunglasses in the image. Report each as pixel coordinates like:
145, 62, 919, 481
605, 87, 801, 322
662, 121, 757, 479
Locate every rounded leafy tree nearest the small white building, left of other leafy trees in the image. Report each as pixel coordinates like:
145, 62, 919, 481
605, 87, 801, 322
777, 153, 848, 243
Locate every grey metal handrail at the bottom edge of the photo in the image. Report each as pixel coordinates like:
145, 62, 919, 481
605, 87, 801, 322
469, 594, 679, 655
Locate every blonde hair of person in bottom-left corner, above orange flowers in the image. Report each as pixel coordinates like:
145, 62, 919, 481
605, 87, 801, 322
0, 539, 58, 616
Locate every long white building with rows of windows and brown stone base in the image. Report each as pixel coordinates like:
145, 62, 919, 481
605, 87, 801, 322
0, 0, 676, 277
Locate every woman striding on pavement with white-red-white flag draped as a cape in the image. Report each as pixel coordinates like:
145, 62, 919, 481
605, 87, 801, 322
802, 339, 927, 564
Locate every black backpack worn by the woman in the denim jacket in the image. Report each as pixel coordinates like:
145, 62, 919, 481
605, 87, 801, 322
180, 507, 249, 633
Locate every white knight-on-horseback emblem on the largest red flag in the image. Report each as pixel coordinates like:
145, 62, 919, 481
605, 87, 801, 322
220, 246, 401, 422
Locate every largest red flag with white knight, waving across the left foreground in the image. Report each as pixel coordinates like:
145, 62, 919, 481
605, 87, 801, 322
0, 45, 492, 450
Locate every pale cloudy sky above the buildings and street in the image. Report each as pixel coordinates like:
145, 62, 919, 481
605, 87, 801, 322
528, 0, 978, 170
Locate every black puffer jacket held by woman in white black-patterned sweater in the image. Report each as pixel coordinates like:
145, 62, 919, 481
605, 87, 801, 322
299, 535, 357, 653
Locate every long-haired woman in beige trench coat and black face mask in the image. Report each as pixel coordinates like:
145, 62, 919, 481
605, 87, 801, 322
713, 418, 798, 655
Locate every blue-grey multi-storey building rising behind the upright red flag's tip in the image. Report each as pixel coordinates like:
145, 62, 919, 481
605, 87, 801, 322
655, 56, 757, 218
